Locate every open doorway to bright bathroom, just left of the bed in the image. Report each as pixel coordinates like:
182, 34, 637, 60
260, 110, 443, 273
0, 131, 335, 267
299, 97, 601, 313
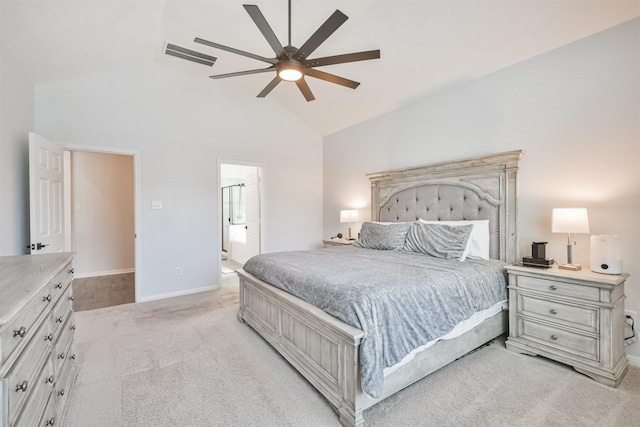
218, 161, 264, 286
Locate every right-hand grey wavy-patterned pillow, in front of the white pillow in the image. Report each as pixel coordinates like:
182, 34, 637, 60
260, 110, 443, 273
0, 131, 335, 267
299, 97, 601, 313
404, 221, 473, 261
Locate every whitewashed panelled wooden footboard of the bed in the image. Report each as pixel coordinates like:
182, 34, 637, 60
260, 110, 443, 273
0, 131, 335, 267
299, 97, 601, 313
238, 270, 364, 426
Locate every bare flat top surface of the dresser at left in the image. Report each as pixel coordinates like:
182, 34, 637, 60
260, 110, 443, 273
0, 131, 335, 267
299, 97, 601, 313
0, 252, 73, 327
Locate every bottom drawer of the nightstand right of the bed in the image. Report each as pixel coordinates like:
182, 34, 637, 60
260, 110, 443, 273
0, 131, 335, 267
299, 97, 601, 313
519, 319, 600, 361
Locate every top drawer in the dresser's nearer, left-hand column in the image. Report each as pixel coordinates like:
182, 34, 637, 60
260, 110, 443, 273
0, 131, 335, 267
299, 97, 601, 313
0, 287, 52, 363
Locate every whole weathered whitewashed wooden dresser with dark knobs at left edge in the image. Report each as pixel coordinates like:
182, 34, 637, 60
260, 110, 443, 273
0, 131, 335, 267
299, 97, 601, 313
0, 253, 76, 427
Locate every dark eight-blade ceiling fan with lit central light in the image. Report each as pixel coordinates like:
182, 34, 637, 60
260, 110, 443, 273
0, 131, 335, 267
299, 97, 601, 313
194, 0, 380, 101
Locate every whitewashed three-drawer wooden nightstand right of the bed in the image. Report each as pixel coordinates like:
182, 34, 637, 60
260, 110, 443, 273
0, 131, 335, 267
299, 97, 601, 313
505, 266, 629, 387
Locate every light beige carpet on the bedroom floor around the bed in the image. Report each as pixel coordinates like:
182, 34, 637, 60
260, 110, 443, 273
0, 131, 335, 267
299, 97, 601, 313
65, 287, 640, 427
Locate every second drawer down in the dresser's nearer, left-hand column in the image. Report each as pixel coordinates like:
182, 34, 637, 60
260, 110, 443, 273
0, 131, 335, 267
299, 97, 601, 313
7, 321, 52, 424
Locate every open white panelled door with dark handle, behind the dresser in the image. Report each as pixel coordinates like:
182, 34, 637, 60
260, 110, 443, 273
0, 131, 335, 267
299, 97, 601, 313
29, 132, 64, 254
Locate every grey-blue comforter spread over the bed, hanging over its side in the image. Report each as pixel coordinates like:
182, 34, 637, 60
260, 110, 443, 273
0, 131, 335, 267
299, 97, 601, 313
244, 246, 507, 397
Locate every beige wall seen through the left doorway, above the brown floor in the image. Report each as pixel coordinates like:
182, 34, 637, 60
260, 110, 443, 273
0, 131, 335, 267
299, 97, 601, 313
71, 151, 135, 277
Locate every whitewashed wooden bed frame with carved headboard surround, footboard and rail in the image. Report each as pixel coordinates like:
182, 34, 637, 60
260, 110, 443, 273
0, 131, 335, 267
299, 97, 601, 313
238, 151, 522, 426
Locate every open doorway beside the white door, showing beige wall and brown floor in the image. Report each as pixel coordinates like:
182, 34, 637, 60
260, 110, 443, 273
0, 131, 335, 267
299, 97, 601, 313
65, 149, 136, 311
